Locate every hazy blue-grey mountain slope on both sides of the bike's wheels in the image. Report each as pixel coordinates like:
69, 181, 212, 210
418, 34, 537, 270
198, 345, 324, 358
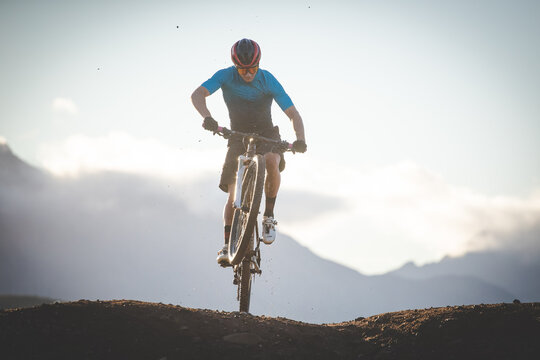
0, 142, 532, 322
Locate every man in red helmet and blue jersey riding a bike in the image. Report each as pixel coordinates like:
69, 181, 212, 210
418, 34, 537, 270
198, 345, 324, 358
191, 39, 307, 266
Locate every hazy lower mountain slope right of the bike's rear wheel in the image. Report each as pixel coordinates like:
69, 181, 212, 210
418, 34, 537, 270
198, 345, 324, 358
253, 238, 514, 322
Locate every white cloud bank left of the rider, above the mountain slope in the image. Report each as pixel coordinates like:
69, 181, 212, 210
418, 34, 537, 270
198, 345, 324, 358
38, 131, 223, 180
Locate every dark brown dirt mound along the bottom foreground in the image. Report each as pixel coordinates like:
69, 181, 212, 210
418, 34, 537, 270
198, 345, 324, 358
0, 300, 540, 360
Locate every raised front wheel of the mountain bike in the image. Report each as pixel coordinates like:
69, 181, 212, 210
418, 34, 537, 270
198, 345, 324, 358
229, 155, 265, 265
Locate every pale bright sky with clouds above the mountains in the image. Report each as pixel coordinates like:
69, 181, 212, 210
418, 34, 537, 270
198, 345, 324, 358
0, 0, 540, 274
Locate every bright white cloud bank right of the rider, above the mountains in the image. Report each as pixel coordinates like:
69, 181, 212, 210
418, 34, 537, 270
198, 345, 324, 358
278, 158, 540, 274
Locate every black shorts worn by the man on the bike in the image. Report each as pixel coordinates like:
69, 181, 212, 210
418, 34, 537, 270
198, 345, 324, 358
219, 126, 285, 192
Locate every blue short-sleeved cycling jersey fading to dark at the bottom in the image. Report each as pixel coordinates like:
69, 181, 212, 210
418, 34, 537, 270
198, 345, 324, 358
201, 66, 293, 132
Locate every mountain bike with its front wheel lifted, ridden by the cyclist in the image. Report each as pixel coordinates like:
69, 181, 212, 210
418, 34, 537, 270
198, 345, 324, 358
210, 126, 292, 312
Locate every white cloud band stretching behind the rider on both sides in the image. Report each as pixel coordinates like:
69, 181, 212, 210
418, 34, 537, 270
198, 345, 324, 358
35, 132, 540, 274
